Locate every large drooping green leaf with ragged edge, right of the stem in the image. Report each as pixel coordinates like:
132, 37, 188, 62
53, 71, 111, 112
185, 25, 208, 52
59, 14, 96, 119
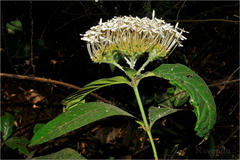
141, 64, 216, 137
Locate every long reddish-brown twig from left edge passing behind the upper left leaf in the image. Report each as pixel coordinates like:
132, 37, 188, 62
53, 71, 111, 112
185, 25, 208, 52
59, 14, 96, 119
0, 73, 113, 104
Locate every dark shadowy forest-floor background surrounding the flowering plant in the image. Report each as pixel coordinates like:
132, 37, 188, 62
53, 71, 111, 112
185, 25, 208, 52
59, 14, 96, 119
1, 1, 239, 158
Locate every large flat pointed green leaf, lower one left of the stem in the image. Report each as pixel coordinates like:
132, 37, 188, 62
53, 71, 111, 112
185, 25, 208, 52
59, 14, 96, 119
30, 102, 133, 146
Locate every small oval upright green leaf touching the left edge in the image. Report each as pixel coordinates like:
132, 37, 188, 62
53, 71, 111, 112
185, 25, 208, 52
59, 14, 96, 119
1, 112, 14, 140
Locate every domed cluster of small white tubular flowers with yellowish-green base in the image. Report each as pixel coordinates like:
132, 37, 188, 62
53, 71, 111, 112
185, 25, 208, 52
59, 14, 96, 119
82, 11, 186, 68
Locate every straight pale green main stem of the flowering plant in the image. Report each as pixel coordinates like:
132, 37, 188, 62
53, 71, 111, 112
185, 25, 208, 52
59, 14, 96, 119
133, 84, 158, 160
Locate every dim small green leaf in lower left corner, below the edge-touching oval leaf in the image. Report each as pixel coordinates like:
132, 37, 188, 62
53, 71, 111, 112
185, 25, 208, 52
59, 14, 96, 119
6, 137, 29, 155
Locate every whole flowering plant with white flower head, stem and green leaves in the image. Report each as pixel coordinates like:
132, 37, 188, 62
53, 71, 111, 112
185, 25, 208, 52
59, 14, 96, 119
30, 11, 216, 159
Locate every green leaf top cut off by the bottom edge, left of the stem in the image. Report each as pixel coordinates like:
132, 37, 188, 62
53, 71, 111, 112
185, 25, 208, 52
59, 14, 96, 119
33, 148, 86, 159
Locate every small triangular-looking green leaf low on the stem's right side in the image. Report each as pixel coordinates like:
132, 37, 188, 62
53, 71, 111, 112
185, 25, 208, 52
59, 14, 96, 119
148, 107, 180, 128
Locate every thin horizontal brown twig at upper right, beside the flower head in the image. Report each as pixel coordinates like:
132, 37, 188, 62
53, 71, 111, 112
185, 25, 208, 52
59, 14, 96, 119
166, 19, 240, 23
